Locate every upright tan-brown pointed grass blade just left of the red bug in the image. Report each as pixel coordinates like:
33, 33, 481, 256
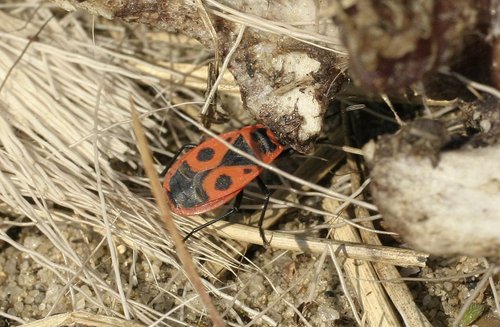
130, 98, 225, 327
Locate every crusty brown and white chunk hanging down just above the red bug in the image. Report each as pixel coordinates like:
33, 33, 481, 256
49, 0, 347, 152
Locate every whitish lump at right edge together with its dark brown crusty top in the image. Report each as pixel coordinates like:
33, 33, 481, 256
364, 113, 500, 259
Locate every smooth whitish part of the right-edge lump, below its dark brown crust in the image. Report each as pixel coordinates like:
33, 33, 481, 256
366, 145, 500, 257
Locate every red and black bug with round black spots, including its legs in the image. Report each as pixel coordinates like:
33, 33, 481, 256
163, 125, 284, 243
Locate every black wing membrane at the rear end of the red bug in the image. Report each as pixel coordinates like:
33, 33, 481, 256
167, 162, 210, 208
